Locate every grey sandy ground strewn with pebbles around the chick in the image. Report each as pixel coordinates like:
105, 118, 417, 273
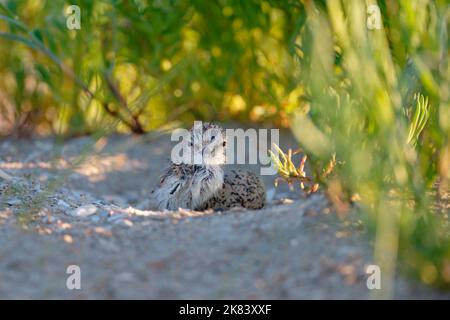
0, 129, 450, 299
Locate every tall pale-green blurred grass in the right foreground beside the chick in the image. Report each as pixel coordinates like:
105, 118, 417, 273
292, 0, 450, 297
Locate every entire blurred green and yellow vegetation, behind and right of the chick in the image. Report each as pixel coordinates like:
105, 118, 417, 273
0, 0, 450, 294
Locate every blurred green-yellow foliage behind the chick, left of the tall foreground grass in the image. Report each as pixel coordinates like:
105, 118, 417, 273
0, 0, 301, 134
